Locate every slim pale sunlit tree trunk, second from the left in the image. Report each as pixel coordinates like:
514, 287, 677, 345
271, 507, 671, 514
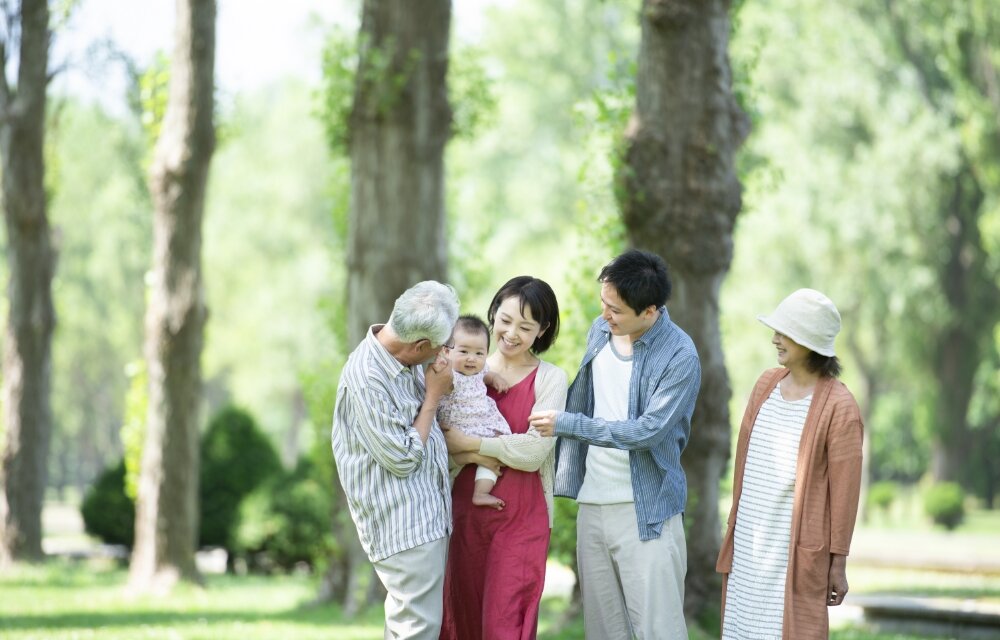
130, 0, 216, 590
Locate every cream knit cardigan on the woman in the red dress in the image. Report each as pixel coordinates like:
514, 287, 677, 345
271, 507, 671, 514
479, 360, 568, 529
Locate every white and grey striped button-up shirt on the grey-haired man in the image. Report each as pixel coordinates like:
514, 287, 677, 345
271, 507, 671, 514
331, 325, 451, 562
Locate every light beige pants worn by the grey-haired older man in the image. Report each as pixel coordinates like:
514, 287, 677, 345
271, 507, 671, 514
372, 537, 448, 640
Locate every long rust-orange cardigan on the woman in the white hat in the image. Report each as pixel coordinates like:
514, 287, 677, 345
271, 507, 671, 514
715, 368, 864, 640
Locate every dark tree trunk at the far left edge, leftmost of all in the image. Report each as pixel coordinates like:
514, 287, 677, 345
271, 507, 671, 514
0, 0, 55, 564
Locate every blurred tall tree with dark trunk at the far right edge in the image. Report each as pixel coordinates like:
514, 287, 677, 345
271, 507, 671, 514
883, 0, 1000, 485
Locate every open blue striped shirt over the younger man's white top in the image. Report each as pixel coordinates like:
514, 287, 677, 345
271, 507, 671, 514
555, 307, 701, 540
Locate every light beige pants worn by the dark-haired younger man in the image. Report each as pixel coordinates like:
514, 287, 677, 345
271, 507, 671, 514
576, 502, 688, 640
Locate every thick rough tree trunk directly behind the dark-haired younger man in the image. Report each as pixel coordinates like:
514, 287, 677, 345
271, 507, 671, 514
617, 0, 748, 618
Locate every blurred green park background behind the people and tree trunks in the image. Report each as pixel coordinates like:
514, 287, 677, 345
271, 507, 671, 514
0, 0, 1000, 638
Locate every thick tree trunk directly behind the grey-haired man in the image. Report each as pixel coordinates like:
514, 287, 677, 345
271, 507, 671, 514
323, 0, 451, 612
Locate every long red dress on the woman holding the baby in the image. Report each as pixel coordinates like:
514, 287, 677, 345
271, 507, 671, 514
441, 368, 549, 640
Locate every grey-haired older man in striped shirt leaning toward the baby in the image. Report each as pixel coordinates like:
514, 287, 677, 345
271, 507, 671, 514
331, 280, 459, 640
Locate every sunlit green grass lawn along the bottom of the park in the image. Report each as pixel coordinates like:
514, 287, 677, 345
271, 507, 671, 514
9, 500, 1000, 640
